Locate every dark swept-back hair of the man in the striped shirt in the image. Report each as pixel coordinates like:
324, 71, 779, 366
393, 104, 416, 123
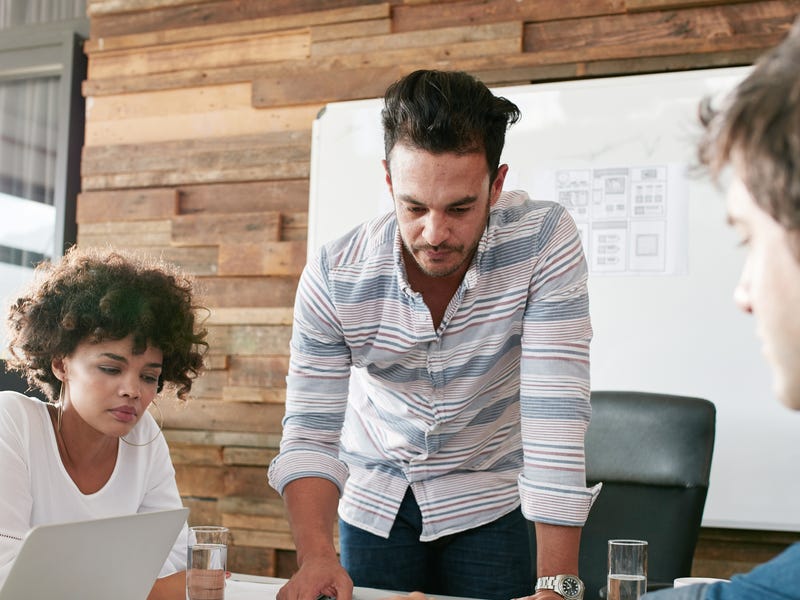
381, 70, 520, 181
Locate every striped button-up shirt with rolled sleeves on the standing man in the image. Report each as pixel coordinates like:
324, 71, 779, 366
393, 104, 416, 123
269, 192, 599, 541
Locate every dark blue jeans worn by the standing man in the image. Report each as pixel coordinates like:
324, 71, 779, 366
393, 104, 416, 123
339, 488, 533, 600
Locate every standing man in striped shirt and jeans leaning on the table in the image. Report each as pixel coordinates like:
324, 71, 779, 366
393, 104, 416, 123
269, 71, 599, 600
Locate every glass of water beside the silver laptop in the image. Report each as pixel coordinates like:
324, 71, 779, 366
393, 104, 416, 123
186, 526, 228, 600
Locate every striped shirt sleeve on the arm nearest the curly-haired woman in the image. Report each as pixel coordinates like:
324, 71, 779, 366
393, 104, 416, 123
268, 250, 351, 494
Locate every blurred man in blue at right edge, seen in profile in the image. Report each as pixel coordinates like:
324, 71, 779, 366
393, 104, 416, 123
645, 14, 800, 600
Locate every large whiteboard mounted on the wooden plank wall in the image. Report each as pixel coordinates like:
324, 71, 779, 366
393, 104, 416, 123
309, 67, 800, 531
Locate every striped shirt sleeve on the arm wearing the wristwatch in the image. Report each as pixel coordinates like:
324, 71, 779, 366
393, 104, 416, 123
519, 207, 600, 526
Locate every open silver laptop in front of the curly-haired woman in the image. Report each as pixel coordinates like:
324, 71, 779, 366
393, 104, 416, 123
0, 508, 189, 600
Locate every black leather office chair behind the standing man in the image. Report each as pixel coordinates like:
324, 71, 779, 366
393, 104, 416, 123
580, 391, 716, 600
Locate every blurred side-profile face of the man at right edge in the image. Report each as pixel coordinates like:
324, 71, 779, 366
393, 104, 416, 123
728, 177, 800, 410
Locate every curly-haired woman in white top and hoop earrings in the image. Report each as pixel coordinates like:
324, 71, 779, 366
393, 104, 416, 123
0, 249, 207, 599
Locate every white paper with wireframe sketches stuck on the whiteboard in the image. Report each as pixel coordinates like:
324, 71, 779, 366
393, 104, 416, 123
532, 164, 688, 275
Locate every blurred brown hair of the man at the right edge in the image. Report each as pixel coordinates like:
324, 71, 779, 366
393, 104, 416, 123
700, 19, 800, 232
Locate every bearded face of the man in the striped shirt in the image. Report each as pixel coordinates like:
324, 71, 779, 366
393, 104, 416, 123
384, 144, 508, 277
